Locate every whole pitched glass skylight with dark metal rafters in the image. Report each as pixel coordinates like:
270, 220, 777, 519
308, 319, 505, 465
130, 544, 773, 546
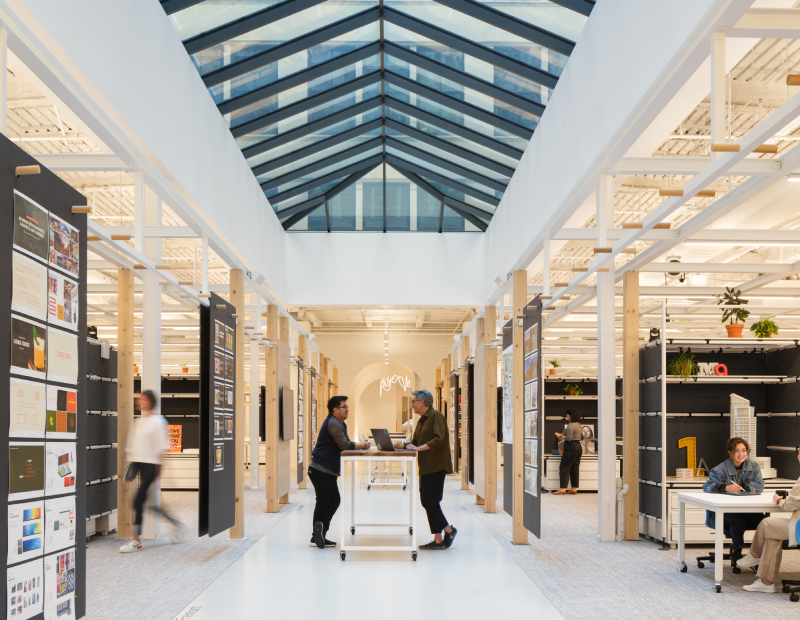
161, 0, 594, 232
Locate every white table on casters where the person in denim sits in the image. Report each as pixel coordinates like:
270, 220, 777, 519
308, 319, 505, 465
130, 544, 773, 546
678, 491, 785, 592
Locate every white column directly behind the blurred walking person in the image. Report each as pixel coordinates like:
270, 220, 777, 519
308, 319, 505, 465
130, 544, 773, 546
141, 183, 162, 538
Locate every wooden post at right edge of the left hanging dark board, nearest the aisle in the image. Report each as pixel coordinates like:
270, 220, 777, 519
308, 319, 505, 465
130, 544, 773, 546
228, 269, 245, 540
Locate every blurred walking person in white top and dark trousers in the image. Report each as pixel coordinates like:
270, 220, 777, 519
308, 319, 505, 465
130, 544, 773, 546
119, 390, 183, 553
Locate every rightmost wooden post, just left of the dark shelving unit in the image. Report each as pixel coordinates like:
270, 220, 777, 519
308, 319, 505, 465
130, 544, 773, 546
622, 271, 639, 540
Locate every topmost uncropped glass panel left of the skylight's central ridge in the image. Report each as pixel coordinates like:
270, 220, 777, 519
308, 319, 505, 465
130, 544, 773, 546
208, 22, 380, 105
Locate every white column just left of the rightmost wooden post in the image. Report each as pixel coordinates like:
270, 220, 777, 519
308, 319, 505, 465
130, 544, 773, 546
597, 174, 617, 541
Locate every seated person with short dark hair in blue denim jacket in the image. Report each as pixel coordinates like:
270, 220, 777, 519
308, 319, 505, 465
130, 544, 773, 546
703, 437, 765, 560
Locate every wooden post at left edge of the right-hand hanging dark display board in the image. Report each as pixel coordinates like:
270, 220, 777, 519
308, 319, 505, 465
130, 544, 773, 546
511, 270, 528, 545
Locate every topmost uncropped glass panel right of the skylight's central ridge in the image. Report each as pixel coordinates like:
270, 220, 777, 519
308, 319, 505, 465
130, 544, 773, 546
383, 23, 553, 105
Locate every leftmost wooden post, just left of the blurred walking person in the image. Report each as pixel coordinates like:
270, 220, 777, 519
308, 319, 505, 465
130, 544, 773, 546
117, 269, 134, 538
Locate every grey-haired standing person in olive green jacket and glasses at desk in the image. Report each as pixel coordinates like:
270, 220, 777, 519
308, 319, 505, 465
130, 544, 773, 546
404, 390, 458, 550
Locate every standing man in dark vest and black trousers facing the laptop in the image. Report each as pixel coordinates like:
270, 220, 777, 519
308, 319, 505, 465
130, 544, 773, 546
308, 396, 369, 549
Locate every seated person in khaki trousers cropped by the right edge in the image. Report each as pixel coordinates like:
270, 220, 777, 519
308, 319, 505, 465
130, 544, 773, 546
726, 446, 800, 594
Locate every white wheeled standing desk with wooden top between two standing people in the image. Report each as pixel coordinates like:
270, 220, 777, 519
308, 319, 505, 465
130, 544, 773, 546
339, 450, 417, 562
